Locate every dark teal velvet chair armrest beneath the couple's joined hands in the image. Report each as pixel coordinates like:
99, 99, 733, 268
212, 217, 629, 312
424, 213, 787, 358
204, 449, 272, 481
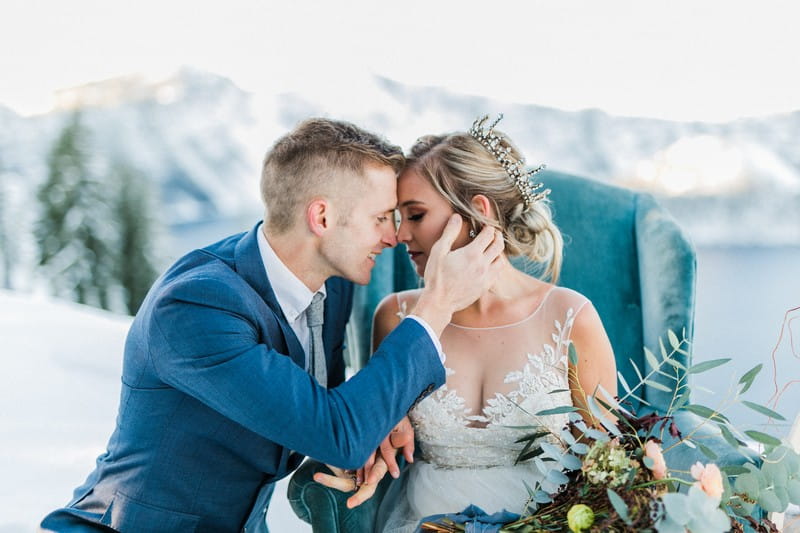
287, 459, 391, 533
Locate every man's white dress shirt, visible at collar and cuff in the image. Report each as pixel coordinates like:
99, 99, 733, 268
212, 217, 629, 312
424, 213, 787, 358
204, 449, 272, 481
258, 226, 445, 364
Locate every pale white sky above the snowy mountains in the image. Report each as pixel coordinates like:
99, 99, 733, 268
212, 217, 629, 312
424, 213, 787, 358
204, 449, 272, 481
0, 0, 800, 121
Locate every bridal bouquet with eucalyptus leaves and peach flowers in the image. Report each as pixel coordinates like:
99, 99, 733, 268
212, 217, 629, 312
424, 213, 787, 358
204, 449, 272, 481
422, 331, 800, 533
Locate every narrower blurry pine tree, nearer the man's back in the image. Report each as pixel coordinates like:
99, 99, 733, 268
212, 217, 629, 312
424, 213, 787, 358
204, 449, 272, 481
112, 163, 157, 315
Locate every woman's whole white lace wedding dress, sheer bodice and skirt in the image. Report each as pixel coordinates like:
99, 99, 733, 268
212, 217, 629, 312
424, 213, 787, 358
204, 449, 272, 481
377, 287, 588, 533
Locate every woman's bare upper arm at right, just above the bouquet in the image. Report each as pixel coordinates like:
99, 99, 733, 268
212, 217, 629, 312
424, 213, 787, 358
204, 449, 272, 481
569, 302, 617, 426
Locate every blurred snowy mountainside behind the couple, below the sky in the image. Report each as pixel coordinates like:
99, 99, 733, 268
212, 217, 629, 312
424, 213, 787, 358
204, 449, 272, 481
0, 69, 800, 249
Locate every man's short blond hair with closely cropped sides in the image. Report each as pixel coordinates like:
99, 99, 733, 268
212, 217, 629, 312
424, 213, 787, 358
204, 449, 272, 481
261, 118, 405, 233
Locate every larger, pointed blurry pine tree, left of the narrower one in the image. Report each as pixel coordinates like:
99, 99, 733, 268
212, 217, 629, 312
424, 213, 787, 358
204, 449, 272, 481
35, 113, 114, 309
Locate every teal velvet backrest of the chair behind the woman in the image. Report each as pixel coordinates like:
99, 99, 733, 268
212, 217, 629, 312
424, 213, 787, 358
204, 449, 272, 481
348, 171, 696, 412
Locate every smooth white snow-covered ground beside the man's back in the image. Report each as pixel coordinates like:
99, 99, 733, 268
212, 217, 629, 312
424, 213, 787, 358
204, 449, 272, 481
0, 291, 311, 533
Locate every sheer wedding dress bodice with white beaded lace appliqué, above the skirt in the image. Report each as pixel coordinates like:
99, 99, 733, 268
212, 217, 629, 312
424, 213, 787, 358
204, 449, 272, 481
400, 287, 587, 468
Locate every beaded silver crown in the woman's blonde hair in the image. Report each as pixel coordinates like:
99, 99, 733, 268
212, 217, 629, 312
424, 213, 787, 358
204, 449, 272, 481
468, 113, 550, 209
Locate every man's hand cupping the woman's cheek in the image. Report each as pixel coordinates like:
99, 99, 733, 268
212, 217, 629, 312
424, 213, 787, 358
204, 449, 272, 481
411, 214, 504, 336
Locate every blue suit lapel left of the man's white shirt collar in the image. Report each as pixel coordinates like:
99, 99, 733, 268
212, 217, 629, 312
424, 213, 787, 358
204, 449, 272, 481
234, 222, 306, 368
